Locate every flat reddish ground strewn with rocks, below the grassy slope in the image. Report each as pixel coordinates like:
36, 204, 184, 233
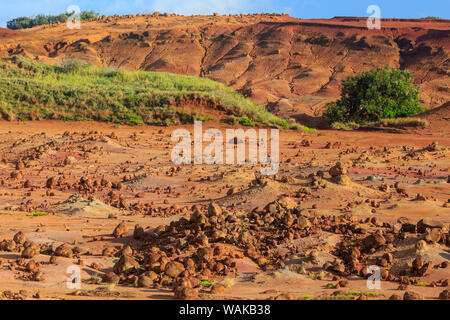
0, 119, 450, 300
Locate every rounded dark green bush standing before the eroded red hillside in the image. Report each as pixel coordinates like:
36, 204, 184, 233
324, 67, 423, 124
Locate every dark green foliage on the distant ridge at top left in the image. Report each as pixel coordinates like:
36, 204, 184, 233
6, 11, 98, 30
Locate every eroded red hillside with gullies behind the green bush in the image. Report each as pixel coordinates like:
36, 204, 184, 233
0, 13, 450, 126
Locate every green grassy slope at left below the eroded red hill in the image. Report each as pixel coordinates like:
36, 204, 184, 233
0, 56, 301, 129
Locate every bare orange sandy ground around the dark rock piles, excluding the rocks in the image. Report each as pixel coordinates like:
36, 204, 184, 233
0, 121, 450, 299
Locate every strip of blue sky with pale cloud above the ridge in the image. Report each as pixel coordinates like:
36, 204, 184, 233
0, 0, 450, 27
